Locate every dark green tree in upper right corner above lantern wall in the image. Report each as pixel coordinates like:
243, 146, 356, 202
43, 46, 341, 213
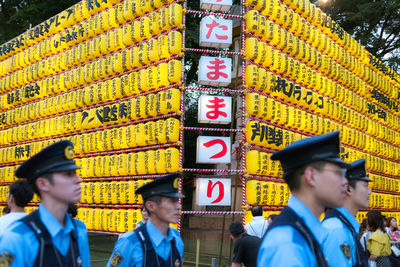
312, 0, 400, 72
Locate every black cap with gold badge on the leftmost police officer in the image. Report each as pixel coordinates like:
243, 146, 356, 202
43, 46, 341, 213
15, 140, 79, 182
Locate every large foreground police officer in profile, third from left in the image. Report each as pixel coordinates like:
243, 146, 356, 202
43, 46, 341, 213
257, 131, 348, 267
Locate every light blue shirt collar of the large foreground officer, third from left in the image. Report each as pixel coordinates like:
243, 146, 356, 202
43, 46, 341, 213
288, 195, 326, 245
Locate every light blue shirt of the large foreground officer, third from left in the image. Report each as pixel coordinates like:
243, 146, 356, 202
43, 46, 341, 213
257, 196, 325, 267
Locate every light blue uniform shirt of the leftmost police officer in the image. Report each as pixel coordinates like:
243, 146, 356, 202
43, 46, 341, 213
0, 204, 90, 267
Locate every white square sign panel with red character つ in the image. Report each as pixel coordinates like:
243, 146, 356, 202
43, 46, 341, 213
196, 136, 231, 163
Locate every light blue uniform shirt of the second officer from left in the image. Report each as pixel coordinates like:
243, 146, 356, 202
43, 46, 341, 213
107, 220, 183, 267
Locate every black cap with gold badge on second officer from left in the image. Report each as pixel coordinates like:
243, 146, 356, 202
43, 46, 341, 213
135, 172, 185, 200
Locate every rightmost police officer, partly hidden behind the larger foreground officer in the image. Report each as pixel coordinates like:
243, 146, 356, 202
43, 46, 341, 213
322, 159, 371, 267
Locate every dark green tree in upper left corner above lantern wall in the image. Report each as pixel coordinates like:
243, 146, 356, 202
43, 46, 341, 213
0, 0, 79, 44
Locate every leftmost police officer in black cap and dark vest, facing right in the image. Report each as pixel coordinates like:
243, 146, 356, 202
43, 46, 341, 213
0, 141, 90, 267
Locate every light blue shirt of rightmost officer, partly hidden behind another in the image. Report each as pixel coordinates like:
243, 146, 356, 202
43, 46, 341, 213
322, 207, 360, 267
